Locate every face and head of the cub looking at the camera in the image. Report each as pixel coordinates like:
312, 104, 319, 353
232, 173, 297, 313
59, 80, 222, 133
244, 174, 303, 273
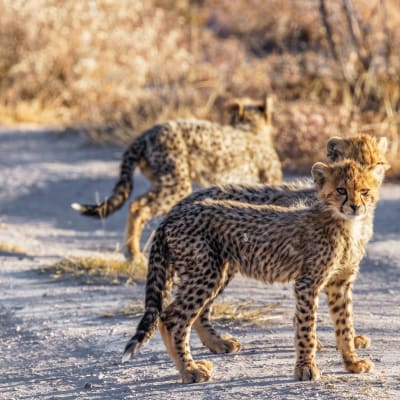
311, 160, 385, 220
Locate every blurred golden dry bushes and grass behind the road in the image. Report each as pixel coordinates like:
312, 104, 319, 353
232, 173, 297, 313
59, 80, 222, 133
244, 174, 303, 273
0, 0, 400, 176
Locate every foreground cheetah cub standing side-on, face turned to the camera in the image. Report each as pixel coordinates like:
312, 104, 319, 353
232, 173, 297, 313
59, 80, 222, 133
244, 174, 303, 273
124, 160, 385, 383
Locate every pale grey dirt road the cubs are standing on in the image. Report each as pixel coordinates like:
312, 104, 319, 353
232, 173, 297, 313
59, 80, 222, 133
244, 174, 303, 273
0, 129, 400, 400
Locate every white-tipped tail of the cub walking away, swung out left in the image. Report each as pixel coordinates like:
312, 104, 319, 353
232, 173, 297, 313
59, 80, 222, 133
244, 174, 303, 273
71, 137, 145, 218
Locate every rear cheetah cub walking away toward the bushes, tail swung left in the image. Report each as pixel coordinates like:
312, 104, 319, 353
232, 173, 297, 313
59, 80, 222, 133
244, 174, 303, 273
71, 99, 282, 258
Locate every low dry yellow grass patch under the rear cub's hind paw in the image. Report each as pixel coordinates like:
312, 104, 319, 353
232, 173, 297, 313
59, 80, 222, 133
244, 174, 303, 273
43, 257, 147, 284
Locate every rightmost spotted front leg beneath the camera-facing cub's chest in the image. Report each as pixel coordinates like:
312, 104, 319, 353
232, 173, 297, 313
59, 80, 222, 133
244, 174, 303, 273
326, 280, 374, 373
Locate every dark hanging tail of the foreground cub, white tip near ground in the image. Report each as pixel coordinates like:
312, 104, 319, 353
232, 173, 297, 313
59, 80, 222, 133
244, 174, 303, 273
122, 225, 174, 362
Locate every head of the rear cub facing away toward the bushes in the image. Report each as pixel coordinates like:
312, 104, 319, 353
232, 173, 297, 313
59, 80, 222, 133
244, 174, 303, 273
228, 97, 272, 127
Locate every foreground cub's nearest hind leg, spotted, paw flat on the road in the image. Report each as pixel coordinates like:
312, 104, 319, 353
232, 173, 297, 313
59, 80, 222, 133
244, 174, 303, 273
159, 258, 228, 383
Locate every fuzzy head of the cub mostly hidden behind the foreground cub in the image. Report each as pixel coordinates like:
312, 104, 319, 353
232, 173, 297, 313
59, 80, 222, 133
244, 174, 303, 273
326, 135, 390, 169
